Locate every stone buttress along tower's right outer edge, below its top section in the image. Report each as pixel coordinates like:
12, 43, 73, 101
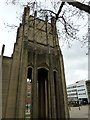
58, 49, 69, 119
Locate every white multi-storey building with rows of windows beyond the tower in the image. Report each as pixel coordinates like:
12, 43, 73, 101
67, 80, 90, 104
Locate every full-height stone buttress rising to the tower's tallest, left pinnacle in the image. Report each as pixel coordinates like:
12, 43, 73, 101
15, 6, 30, 118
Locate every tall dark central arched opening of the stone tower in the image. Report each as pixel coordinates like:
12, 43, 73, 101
38, 68, 48, 118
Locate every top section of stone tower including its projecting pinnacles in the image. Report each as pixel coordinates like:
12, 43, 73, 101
15, 6, 57, 47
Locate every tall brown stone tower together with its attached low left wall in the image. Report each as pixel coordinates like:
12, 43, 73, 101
2, 6, 69, 119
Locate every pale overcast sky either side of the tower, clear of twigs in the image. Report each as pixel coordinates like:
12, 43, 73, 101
0, 0, 88, 85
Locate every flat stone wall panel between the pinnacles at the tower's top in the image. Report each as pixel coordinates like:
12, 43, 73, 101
28, 16, 56, 47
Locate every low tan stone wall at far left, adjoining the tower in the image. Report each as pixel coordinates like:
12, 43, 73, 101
2, 57, 12, 116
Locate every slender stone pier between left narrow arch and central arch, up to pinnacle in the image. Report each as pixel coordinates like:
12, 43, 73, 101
31, 11, 38, 118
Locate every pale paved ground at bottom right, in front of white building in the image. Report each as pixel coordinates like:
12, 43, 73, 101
69, 106, 90, 120
